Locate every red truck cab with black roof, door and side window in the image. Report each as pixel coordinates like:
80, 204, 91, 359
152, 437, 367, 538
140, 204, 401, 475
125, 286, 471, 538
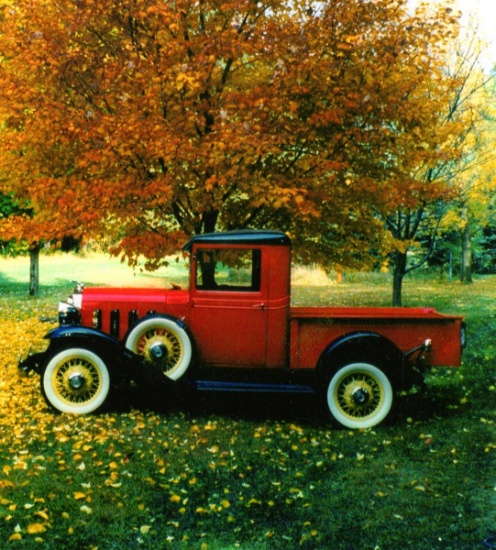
186, 231, 291, 369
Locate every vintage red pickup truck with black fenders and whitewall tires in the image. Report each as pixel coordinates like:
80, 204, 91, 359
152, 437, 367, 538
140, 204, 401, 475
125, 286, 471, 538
19, 230, 465, 428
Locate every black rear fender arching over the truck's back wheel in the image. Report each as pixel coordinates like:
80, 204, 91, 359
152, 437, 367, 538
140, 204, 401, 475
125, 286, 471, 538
317, 331, 411, 390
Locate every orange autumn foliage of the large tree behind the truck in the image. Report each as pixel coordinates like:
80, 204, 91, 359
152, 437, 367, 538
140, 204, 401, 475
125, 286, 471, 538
0, 0, 457, 278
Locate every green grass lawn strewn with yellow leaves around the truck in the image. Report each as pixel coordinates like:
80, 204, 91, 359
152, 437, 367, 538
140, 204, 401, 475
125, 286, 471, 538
0, 256, 496, 550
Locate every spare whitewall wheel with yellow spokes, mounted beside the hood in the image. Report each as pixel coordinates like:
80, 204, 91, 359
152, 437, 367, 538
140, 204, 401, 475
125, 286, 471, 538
126, 317, 192, 380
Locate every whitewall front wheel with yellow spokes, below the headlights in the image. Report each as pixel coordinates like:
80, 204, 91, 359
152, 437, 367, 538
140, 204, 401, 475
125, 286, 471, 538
41, 348, 110, 414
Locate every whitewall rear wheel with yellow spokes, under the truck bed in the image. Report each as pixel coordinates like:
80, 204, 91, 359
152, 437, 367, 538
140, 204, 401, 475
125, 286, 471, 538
326, 363, 393, 429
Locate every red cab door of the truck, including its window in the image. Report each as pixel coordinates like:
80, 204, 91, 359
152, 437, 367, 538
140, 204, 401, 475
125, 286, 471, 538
190, 245, 268, 367
